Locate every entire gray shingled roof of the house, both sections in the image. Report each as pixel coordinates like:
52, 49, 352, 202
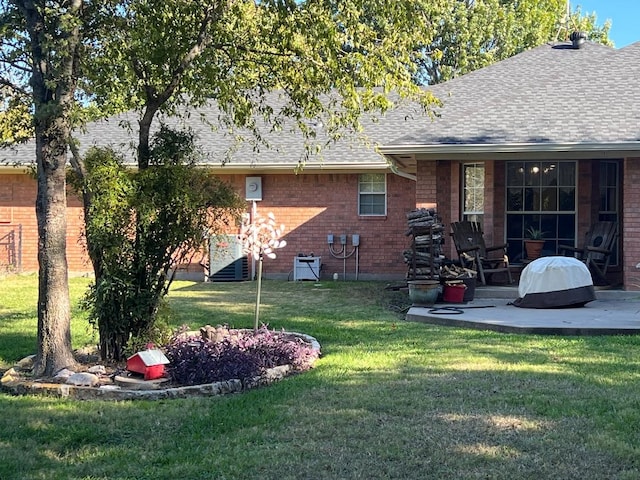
5, 42, 640, 173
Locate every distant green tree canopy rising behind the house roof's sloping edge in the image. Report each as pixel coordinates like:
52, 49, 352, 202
415, 0, 612, 84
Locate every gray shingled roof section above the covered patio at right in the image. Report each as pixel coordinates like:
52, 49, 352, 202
381, 42, 640, 158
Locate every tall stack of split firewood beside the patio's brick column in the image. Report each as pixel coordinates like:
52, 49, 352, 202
402, 208, 444, 280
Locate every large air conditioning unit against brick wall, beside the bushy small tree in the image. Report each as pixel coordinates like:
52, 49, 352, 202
209, 235, 249, 282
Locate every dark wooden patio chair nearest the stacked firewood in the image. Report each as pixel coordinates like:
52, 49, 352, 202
451, 221, 513, 285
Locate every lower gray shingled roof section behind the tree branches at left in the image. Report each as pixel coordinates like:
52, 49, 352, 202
0, 92, 426, 174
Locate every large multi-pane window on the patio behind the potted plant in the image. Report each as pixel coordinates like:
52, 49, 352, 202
506, 161, 577, 262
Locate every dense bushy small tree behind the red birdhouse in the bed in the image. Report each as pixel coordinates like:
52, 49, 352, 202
72, 126, 244, 360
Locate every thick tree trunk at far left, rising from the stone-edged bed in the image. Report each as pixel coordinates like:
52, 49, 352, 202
14, 0, 82, 376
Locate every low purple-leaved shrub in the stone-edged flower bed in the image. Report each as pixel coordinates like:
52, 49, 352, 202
165, 326, 318, 385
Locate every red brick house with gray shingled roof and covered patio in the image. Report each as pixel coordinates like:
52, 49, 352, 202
0, 37, 640, 290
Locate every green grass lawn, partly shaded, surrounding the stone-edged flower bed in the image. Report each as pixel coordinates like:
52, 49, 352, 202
0, 277, 640, 480
